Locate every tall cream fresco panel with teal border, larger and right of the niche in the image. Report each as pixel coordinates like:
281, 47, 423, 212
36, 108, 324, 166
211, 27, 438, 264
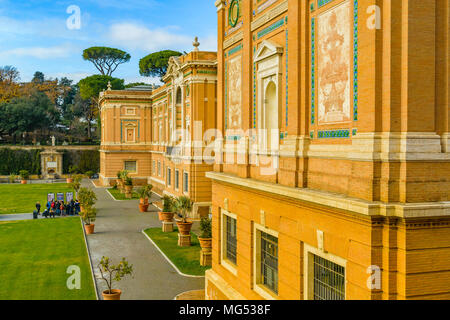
316, 1, 353, 124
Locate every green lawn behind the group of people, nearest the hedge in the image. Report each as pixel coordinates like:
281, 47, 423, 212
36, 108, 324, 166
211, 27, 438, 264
0, 183, 73, 214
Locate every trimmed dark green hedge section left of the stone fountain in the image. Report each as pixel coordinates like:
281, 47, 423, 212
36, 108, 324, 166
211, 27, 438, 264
0, 148, 42, 176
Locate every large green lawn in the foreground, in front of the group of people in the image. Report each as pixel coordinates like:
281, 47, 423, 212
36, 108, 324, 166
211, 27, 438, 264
0, 217, 96, 300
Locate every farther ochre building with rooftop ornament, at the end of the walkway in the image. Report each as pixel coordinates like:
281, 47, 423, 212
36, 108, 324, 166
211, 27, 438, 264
100, 49, 217, 218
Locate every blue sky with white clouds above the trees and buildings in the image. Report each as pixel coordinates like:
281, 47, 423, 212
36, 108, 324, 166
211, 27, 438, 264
0, 0, 217, 83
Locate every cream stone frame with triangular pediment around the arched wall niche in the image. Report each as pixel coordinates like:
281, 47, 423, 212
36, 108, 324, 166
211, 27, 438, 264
253, 40, 284, 149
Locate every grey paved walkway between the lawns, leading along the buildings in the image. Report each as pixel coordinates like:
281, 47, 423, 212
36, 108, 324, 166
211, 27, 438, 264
83, 180, 205, 300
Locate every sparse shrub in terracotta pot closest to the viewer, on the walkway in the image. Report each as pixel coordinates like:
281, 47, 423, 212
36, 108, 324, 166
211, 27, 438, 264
98, 257, 133, 300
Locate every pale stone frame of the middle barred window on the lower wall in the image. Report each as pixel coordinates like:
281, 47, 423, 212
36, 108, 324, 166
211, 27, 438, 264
253, 222, 279, 300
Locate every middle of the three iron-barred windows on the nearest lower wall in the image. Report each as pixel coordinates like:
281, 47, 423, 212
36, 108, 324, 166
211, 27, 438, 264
261, 232, 278, 294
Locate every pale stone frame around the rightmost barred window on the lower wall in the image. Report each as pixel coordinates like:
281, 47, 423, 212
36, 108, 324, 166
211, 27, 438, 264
303, 243, 347, 300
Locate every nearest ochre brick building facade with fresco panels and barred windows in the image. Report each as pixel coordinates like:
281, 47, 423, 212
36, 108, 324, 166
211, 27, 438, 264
205, 0, 450, 300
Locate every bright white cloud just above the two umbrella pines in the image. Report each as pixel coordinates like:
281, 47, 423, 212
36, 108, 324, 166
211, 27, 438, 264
109, 23, 217, 52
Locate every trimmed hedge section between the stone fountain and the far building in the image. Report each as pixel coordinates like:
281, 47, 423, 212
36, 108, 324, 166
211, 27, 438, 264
63, 150, 100, 173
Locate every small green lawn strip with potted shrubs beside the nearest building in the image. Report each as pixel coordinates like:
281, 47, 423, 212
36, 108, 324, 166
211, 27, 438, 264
145, 228, 211, 276
